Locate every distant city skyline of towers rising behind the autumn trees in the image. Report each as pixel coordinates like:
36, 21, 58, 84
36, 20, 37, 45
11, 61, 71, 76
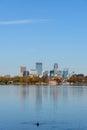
0, 61, 81, 77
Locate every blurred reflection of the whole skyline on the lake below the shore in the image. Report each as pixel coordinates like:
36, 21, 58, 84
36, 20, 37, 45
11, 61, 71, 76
20, 86, 85, 107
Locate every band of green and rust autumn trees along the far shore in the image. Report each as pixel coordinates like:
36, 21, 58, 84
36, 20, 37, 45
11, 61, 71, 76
0, 74, 87, 85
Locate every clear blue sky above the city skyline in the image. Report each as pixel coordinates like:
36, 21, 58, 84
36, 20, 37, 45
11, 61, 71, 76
0, 0, 87, 75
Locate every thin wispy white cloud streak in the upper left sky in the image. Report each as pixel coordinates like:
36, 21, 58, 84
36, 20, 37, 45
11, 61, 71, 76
0, 19, 49, 25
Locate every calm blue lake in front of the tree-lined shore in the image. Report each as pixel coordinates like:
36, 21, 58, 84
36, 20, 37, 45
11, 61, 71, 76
0, 86, 87, 130
